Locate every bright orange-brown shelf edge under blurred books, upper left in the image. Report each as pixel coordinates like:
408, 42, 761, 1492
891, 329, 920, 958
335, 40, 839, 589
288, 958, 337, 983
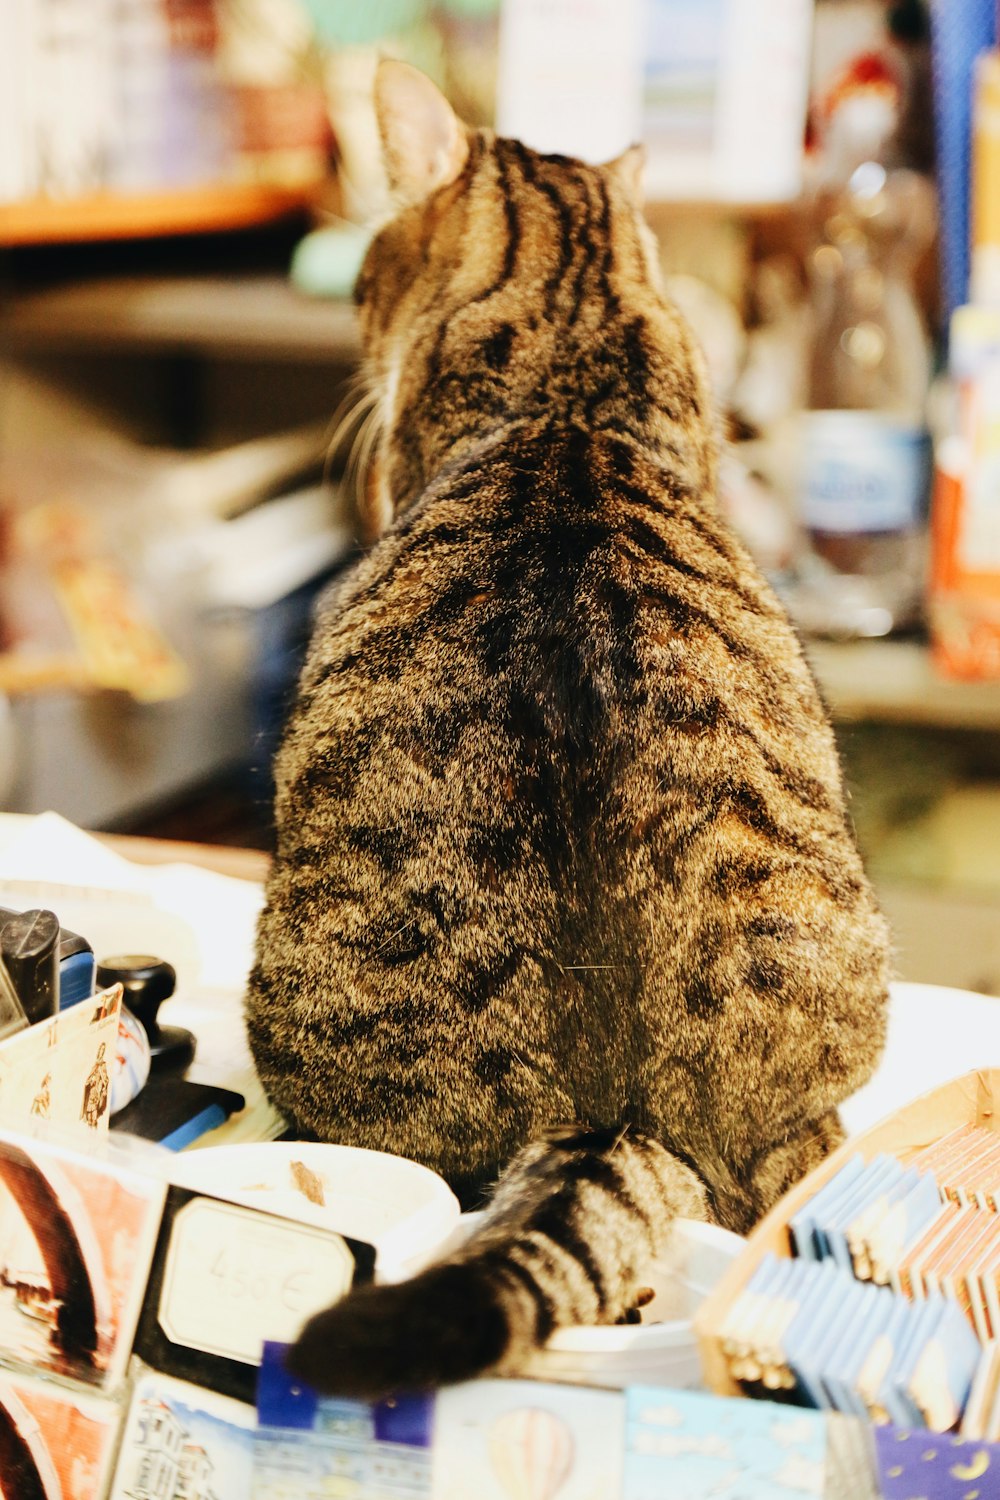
0, 183, 322, 248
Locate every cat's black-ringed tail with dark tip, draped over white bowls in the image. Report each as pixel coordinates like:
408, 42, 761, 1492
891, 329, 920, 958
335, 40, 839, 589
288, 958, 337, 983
288, 1130, 706, 1400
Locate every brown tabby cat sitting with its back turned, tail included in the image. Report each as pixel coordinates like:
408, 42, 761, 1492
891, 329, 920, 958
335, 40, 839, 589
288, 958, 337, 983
247, 63, 888, 1397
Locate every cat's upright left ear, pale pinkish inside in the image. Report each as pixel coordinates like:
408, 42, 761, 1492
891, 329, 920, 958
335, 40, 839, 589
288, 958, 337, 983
375, 57, 469, 204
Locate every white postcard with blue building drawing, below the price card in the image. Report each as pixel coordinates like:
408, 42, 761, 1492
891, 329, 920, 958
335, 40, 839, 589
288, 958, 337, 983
109, 1367, 256, 1500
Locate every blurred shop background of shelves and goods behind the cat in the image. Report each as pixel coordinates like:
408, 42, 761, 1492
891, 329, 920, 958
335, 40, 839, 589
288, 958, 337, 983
0, 0, 1000, 993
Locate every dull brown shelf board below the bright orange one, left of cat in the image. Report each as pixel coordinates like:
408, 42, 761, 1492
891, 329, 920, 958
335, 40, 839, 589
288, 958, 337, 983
4, 276, 360, 365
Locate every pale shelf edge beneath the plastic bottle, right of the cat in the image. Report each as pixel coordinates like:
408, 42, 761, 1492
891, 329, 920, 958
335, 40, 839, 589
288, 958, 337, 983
807, 641, 1000, 731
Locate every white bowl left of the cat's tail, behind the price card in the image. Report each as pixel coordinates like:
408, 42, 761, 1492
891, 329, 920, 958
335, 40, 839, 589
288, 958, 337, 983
171, 1140, 460, 1281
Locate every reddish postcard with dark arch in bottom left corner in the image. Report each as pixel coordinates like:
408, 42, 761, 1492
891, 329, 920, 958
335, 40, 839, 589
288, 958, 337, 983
0, 1370, 121, 1500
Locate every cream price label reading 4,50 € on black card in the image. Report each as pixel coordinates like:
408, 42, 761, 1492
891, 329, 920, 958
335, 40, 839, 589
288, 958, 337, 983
159, 1199, 354, 1365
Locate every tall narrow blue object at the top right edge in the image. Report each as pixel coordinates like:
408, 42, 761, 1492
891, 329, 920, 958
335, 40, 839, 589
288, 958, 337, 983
931, 0, 997, 324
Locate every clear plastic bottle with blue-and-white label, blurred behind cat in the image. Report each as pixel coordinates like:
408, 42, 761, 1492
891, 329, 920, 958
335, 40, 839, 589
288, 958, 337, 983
792, 162, 934, 636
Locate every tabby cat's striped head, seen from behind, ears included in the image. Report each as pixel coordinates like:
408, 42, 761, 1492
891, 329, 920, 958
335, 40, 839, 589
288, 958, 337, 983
355, 60, 710, 536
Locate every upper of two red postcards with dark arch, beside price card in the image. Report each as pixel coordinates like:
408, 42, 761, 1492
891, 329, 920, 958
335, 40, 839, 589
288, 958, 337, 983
0, 1130, 165, 1389
